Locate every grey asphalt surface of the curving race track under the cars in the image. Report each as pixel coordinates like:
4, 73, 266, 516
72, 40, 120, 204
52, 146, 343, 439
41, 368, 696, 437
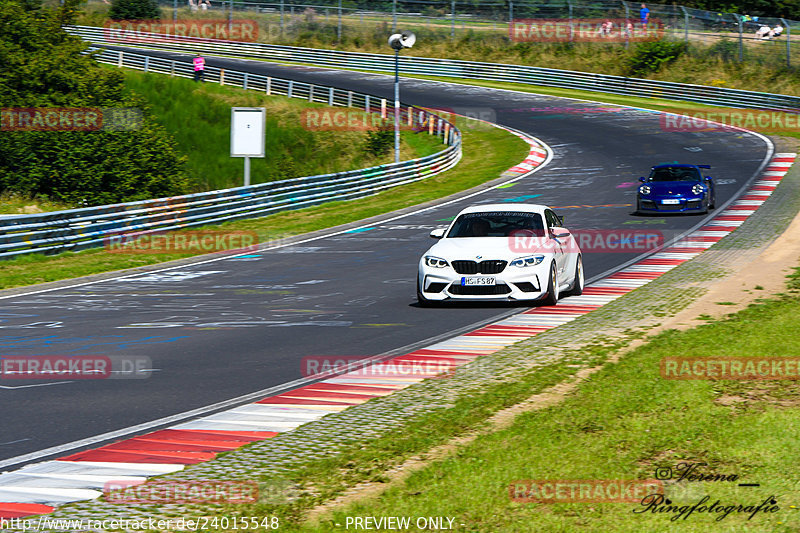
0, 54, 772, 474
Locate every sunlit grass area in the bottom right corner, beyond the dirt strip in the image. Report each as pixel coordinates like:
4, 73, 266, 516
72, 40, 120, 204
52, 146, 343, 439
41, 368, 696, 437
276, 270, 800, 533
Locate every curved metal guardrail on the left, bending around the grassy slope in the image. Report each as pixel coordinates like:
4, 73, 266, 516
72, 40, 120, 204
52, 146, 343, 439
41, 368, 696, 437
0, 46, 461, 258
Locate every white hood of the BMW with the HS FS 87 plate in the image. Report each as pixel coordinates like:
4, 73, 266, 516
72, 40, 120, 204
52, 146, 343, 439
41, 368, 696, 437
425, 237, 551, 261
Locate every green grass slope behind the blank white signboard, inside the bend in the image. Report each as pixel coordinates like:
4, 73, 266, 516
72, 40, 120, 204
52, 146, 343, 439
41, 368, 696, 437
125, 70, 442, 190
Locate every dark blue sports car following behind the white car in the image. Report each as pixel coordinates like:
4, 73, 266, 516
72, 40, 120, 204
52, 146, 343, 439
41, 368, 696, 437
636, 163, 716, 213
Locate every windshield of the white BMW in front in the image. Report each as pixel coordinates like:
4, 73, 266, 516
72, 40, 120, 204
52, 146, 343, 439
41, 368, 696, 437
447, 211, 545, 238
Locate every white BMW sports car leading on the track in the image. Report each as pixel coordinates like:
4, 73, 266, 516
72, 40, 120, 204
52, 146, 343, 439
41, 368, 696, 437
417, 204, 584, 305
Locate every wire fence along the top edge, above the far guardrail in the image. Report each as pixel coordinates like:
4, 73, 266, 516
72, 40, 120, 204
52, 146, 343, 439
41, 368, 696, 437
83, 0, 800, 65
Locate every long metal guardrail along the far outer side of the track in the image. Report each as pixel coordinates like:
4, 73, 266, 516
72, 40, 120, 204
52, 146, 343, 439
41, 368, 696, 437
67, 26, 800, 112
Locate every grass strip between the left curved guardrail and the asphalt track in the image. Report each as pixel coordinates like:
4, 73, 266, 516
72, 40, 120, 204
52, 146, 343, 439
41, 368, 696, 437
0, 118, 528, 288
